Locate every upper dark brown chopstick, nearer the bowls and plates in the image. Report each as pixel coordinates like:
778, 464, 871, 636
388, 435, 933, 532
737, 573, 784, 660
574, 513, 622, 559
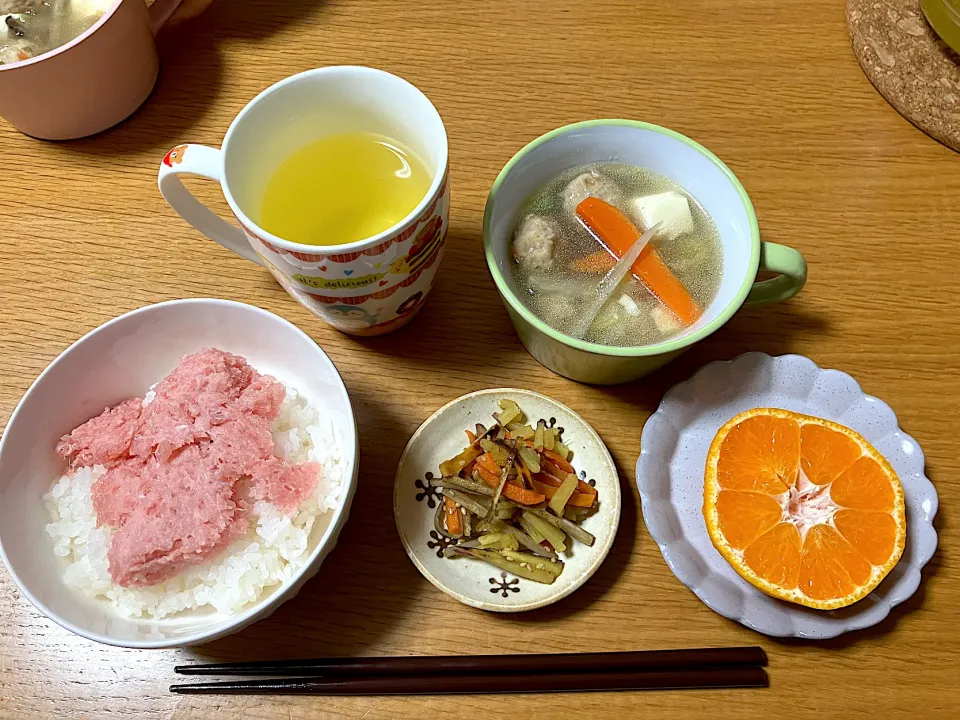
174, 647, 767, 679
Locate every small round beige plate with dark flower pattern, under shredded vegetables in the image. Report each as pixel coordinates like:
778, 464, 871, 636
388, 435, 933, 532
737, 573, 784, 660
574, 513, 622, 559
393, 388, 620, 612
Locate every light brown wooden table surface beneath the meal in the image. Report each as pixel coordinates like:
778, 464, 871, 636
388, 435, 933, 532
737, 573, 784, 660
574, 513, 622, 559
0, 0, 960, 720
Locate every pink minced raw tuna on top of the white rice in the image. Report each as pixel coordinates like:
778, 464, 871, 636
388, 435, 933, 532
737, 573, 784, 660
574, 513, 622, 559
57, 348, 320, 587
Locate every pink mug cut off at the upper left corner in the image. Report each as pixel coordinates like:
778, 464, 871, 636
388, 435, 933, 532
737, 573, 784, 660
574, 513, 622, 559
0, 0, 181, 140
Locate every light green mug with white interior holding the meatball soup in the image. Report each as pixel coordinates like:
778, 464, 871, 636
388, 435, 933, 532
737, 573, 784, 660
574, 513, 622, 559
483, 120, 807, 385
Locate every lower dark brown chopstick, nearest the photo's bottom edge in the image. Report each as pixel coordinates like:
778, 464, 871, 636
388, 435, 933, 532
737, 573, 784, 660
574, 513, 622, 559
170, 666, 769, 695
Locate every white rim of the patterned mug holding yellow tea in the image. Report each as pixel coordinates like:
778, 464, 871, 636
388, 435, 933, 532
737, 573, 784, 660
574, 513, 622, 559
220, 65, 449, 255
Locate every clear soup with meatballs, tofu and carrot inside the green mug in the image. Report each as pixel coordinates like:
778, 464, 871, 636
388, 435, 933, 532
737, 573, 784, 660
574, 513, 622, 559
511, 162, 723, 347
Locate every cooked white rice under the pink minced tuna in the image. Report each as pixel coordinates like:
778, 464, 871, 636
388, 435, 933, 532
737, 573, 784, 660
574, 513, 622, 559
43, 386, 347, 620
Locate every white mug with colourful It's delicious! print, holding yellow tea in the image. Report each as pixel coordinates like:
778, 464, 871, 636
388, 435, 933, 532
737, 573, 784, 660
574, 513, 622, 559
159, 67, 450, 335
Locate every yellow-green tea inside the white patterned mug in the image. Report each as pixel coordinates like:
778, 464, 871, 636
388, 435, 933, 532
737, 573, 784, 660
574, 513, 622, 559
259, 132, 431, 245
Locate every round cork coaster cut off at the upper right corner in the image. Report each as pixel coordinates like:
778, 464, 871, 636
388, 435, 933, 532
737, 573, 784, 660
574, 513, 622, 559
847, 0, 960, 151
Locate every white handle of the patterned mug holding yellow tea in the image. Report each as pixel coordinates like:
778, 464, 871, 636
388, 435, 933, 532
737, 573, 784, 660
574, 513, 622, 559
157, 145, 263, 265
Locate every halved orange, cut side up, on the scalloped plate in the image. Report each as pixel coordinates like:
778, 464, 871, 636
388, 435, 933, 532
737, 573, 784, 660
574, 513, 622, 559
703, 408, 906, 610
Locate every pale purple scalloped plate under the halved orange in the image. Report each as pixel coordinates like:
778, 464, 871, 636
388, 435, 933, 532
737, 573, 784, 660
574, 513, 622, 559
637, 352, 937, 640
